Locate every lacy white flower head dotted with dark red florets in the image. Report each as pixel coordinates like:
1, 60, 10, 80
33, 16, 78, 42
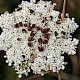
0, 0, 78, 78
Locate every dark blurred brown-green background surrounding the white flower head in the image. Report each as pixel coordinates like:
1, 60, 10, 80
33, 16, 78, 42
0, 0, 80, 80
